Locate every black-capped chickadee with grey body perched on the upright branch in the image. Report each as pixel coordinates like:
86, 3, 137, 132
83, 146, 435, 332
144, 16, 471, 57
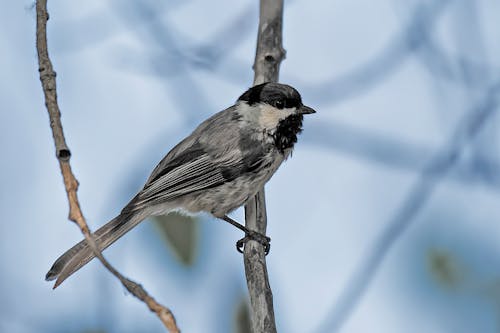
45, 82, 316, 288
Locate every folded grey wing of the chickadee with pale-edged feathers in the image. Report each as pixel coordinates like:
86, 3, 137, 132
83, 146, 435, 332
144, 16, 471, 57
126, 108, 243, 210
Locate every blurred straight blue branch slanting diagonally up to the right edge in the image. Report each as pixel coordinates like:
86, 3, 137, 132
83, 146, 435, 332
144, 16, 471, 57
317, 80, 500, 332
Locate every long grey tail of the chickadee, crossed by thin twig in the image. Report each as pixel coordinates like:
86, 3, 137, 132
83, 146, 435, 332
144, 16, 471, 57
45, 212, 145, 289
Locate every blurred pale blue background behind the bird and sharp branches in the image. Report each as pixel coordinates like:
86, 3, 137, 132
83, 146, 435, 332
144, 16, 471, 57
0, 0, 500, 333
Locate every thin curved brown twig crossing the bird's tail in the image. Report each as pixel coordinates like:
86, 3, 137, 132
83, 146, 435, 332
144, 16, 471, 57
36, 0, 180, 333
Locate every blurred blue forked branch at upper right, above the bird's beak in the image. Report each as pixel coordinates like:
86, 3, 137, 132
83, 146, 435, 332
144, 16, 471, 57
295, 0, 491, 105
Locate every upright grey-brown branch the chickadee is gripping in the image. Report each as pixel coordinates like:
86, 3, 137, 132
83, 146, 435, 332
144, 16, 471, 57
244, 0, 285, 333
